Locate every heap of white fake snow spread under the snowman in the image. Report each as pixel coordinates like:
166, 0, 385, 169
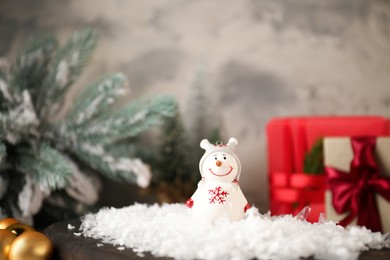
80, 204, 389, 259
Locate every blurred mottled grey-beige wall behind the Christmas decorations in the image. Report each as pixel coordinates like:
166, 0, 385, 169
0, 0, 390, 210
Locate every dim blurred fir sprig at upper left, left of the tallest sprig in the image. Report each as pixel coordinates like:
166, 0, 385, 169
11, 34, 58, 102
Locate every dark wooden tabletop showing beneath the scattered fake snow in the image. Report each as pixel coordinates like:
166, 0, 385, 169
43, 219, 390, 260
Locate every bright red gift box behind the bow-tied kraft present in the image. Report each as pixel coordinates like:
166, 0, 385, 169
267, 116, 390, 222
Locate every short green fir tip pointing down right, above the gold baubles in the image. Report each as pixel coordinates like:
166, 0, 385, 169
16, 143, 71, 191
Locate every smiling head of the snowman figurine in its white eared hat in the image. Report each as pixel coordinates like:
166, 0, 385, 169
199, 138, 241, 182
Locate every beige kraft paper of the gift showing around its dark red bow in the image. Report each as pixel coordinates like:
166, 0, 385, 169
324, 137, 390, 232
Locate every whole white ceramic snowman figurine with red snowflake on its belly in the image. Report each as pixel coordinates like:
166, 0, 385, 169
186, 138, 250, 221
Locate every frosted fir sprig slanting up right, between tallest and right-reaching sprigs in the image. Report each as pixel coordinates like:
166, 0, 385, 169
64, 73, 126, 127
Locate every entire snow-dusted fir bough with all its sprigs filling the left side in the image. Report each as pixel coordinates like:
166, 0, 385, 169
0, 29, 177, 223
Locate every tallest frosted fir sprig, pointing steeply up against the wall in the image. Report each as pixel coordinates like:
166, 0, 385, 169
37, 29, 97, 119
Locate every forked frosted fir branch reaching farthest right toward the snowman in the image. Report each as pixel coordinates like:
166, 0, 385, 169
50, 91, 177, 186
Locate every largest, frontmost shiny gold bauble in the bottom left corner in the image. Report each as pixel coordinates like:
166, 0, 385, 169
9, 231, 53, 260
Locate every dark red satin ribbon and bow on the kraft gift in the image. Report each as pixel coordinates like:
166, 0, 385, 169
325, 137, 390, 231
